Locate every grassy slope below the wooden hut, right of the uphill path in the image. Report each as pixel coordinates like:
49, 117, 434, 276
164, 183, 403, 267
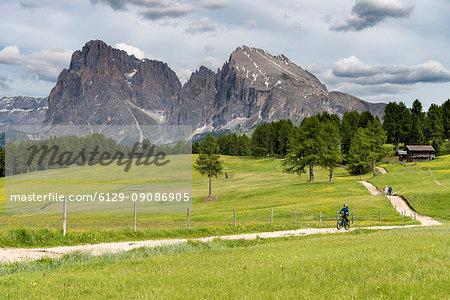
370, 155, 450, 220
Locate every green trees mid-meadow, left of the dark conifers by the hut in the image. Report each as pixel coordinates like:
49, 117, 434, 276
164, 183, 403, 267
192, 111, 386, 182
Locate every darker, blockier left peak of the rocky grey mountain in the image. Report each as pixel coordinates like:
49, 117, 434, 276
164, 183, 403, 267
45, 40, 181, 125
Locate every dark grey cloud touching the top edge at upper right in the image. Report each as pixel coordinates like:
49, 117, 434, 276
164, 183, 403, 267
330, 0, 414, 31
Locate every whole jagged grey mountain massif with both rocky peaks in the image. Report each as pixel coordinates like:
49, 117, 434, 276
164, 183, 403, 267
7, 40, 385, 134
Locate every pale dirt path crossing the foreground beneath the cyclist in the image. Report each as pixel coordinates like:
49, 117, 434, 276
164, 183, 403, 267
0, 225, 419, 263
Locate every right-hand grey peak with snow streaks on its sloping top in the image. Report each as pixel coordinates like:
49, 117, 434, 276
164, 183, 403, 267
169, 46, 385, 133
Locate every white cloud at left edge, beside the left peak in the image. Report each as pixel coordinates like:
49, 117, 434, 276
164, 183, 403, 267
0, 46, 73, 81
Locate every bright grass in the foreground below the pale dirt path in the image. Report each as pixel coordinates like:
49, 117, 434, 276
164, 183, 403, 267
0, 226, 450, 299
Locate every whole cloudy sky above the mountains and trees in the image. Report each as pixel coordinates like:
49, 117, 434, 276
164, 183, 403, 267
0, 0, 450, 107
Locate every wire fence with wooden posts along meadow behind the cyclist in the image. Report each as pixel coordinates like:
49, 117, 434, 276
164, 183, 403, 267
52, 207, 416, 233
